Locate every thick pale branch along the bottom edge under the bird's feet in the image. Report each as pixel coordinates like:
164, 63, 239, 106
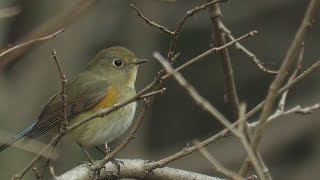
57, 159, 221, 180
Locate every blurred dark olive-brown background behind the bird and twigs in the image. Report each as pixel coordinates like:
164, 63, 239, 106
0, 0, 320, 180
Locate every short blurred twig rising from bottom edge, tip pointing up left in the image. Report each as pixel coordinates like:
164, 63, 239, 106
193, 140, 245, 180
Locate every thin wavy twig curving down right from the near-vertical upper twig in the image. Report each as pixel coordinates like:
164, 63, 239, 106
220, 22, 278, 74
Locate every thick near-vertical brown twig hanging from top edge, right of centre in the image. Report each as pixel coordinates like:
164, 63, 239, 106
209, 4, 239, 119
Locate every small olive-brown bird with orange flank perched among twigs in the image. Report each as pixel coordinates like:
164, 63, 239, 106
0, 46, 147, 152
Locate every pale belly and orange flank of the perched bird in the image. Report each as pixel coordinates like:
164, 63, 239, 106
71, 87, 137, 146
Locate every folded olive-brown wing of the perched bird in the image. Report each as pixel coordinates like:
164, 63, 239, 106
26, 76, 108, 139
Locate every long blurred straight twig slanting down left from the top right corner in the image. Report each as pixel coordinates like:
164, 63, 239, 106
241, 0, 320, 175
